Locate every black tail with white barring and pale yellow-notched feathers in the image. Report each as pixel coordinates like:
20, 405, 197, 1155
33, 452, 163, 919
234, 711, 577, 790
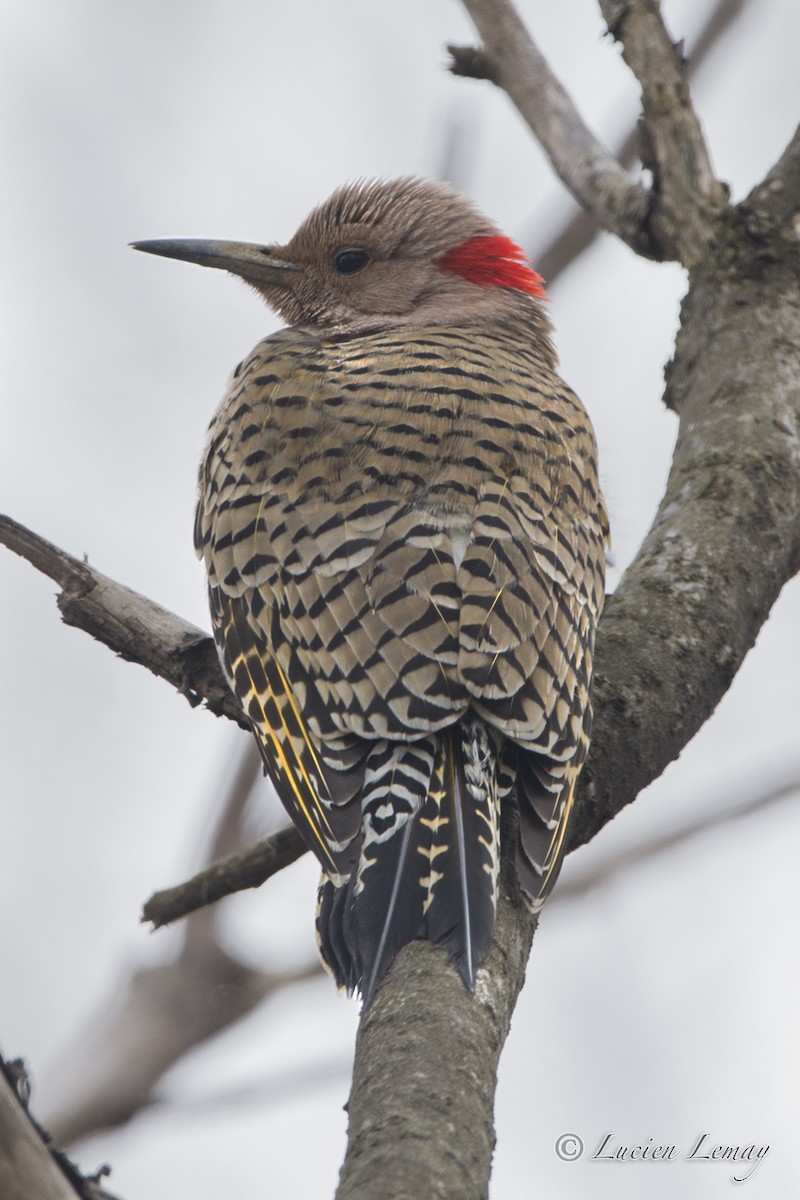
317, 718, 499, 1006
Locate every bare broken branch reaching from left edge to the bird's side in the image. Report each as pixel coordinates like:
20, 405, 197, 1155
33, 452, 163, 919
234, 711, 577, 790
0, 514, 248, 728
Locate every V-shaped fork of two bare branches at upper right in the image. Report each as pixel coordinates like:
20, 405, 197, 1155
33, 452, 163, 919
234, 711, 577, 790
449, 0, 728, 266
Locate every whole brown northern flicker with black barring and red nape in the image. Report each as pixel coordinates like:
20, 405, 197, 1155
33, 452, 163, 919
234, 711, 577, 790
136, 178, 608, 1004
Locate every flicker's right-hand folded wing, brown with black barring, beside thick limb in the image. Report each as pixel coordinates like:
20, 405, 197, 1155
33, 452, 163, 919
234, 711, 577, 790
458, 429, 607, 907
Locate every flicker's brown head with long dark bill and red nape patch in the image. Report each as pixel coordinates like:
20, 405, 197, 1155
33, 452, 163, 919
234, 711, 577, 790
134, 178, 552, 353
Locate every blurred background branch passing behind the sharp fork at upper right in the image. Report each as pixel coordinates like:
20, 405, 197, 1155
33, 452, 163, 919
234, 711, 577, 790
530, 0, 746, 287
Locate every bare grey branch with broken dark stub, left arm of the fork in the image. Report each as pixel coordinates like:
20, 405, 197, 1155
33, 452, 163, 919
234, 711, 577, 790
449, 0, 661, 258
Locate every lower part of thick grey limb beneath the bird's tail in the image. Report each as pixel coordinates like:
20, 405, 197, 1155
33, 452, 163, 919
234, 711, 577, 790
336, 809, 536, 1200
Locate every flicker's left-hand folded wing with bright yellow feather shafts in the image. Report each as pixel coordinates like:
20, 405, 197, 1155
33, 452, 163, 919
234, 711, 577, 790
196, 334, 468, 875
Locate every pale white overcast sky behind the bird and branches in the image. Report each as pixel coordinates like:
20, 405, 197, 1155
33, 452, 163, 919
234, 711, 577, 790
0, 0, 800, 1200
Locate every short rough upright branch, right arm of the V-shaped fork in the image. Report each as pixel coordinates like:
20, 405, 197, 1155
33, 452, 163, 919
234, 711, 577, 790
600, 0, 728, 266
